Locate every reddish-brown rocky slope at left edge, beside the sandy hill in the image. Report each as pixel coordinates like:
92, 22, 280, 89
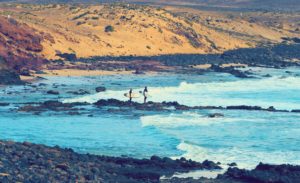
0, 16, 45, 72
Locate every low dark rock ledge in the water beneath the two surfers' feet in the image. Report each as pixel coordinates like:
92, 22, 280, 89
16, 99, 300, 113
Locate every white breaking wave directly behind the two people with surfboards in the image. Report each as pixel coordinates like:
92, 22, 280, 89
64, 77, 300, 109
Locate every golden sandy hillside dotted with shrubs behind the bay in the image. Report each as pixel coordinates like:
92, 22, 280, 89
0, 4, 300, 59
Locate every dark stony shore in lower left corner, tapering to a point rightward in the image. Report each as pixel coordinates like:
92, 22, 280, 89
0, 141, 220, 182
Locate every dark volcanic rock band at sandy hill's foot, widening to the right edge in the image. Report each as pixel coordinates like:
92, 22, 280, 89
79, 44, 300, 70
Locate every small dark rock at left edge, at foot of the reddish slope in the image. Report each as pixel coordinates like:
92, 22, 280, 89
0, 70, 24, 85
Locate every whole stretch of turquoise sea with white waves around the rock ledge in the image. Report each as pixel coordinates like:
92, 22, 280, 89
0, 68, 300, 168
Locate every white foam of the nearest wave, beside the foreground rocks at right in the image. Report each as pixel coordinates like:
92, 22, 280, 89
172, 142, 300, 169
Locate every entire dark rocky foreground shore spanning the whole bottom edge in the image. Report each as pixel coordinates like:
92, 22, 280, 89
0, 140, 300, 183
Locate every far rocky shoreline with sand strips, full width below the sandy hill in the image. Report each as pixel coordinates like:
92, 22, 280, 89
0, 42, 300, 85
